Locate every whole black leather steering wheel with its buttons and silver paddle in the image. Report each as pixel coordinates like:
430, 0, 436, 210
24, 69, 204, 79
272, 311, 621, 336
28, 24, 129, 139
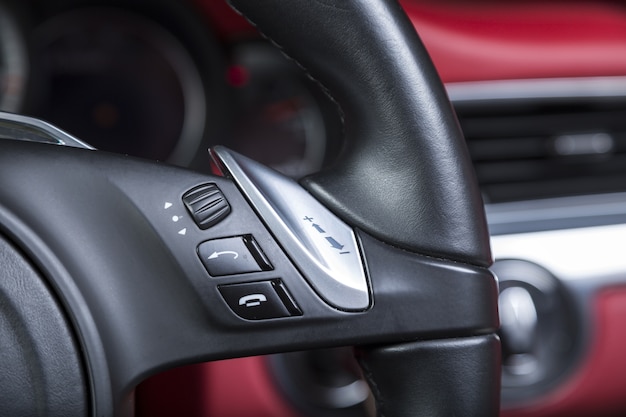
0, 0, 500, 417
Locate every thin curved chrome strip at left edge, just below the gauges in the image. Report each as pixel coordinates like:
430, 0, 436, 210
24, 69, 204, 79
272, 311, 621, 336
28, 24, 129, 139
0, 112, 95, 150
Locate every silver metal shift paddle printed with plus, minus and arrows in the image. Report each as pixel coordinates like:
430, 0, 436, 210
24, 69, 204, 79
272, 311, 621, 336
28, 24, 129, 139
213, 147, 370, 311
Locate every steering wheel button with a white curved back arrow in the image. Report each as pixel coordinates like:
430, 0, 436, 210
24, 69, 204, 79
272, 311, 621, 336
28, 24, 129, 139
198, 235, 273, 277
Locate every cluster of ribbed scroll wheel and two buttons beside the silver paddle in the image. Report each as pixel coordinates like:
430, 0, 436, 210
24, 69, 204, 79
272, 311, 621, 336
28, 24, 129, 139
178, 179, 302, 321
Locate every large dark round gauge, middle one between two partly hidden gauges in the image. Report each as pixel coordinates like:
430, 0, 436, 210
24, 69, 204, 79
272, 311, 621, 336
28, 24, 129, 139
29, 7, 213, 165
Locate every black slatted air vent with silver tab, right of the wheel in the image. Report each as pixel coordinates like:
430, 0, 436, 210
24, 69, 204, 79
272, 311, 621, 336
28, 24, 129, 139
456, 97, 626, 203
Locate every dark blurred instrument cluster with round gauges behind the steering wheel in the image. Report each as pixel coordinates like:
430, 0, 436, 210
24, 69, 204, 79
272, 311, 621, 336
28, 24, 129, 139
0, 0, 341, 177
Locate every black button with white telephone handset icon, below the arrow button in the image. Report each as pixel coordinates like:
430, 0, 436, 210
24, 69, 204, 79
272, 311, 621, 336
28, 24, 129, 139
219, 280, 301, 320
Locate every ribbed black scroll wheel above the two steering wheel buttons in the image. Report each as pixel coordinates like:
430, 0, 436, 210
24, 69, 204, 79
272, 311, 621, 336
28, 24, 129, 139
183, 184, 230, 230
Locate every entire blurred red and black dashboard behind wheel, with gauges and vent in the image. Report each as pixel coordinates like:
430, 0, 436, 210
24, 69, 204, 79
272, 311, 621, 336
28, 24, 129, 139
0, 0, 626, 417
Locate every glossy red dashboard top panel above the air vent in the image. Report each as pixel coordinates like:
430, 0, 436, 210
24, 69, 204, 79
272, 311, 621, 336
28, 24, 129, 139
404, 2, 626, 82
